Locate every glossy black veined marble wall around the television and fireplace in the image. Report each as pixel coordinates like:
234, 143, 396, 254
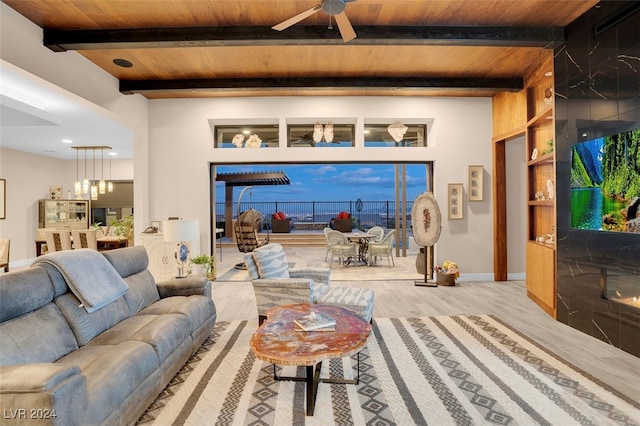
554, 1, 640, 356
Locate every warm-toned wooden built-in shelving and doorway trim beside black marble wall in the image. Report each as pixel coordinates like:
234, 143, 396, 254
493, 50, 556, 317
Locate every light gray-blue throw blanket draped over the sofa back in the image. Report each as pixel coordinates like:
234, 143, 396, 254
31, 249, 129, 313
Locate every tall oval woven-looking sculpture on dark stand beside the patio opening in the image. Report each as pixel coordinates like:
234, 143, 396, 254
411, 192, 442, 287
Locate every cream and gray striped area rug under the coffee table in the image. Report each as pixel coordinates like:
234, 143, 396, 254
139, 316, 640, 426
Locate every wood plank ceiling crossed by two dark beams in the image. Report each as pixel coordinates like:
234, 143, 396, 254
3, 0, 598, 99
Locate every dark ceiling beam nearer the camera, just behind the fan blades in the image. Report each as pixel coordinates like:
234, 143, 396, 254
43, 25, 564, 52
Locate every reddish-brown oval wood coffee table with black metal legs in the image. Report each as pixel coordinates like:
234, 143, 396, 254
249, 303, 371, 416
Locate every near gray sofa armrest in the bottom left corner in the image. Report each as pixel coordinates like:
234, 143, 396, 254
0, 363, 88, 425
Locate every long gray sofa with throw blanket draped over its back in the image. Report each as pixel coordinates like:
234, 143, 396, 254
0, 246, 216, 425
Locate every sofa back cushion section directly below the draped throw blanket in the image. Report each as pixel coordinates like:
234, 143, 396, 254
55, 293, 131, 346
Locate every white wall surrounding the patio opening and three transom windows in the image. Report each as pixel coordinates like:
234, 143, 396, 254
149, 97, 493, 279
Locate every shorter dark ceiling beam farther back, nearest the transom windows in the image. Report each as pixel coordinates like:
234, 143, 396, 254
120, 77, 524, 94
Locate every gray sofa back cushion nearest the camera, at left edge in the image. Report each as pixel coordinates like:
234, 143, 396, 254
0, 302, 78, 365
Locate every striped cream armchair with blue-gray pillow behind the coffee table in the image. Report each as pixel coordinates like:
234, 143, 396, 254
245, 244, 331, 323
